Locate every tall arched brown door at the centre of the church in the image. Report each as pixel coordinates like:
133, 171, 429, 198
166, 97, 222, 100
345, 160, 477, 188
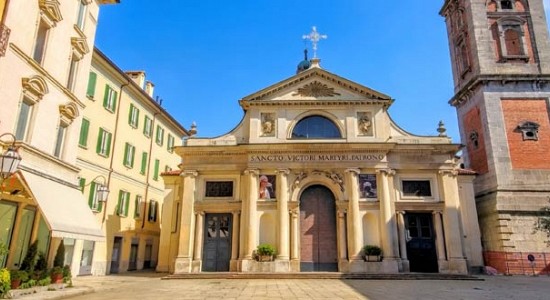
300, 185, 338, 272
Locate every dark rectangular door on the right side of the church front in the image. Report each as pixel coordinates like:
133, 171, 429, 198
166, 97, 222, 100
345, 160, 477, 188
405, 213, 438, 273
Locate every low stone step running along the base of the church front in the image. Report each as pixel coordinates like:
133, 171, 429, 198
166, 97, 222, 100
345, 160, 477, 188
162, 272, 483, 281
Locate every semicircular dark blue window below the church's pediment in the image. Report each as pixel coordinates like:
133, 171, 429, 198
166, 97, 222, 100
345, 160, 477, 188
292, 116, 342, 139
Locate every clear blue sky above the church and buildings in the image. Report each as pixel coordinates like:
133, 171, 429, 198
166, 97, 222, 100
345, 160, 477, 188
96, 0, 549, 142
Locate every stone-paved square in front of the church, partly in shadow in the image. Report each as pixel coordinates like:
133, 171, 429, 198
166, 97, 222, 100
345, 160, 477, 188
14, 273, 550, 300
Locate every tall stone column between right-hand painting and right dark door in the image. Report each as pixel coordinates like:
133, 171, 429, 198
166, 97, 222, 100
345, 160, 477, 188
377, 169, 399, 260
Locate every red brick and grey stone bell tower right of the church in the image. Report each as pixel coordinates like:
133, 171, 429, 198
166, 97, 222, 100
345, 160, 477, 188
440, 0, 550, 274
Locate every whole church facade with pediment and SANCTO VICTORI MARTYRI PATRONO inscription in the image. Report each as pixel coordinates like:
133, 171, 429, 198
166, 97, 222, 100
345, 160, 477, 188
157, 59, 483, 274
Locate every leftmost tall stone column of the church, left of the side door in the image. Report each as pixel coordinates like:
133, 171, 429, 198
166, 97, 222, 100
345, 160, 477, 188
174, 170, 198, 274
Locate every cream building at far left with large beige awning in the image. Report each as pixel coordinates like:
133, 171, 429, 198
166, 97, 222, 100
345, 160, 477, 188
0, 0, 118, 275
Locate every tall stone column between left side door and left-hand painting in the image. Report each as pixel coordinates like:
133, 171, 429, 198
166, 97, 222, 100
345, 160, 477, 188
244, 169, 259, 260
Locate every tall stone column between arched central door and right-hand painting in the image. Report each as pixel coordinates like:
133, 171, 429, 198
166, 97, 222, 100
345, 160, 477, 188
346, 169, 363, 260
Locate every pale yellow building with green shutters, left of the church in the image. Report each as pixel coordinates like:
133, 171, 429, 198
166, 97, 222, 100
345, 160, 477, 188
77, 49, 187, 275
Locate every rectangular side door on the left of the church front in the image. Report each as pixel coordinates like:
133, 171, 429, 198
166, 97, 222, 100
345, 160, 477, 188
202, 214, 232, 272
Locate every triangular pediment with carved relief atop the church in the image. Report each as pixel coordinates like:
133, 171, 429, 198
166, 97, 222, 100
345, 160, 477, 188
241, 68, 393, 107
